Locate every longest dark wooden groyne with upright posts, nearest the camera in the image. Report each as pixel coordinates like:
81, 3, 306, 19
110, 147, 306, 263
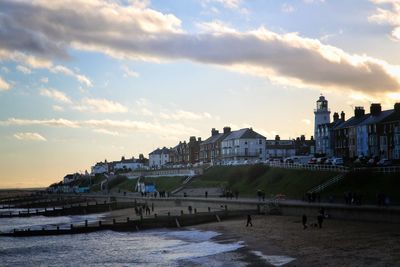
0, 210, 258, 237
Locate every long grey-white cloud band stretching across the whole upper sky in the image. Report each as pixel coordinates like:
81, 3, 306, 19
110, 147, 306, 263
0, 0, 400, 95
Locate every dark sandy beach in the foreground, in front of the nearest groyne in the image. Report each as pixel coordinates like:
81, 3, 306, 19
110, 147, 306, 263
195, 215, 400, 266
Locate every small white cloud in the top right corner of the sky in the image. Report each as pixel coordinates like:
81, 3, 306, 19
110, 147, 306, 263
368, 0, 400, 41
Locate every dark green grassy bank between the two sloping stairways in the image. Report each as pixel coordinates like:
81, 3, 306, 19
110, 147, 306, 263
190, 164, 336, 199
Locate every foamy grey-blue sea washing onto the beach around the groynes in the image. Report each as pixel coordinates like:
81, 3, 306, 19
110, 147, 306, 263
0, 211, 294, 267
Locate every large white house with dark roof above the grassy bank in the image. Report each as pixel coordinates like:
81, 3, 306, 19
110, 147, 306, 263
221, 128, 266, 164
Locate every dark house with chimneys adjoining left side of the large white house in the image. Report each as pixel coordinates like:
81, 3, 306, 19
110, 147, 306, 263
200, 127, 231, 164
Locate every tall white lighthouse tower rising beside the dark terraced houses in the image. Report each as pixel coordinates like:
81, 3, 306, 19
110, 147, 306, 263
314, 95, 331, 154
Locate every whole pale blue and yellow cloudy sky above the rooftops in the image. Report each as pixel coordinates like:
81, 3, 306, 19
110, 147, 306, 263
0, 0, 400, 188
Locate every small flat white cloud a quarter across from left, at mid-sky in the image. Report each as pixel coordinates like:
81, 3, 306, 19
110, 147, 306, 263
73, 98, 128, 113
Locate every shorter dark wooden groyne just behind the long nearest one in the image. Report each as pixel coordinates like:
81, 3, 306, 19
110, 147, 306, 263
0, 201, 137, 218
